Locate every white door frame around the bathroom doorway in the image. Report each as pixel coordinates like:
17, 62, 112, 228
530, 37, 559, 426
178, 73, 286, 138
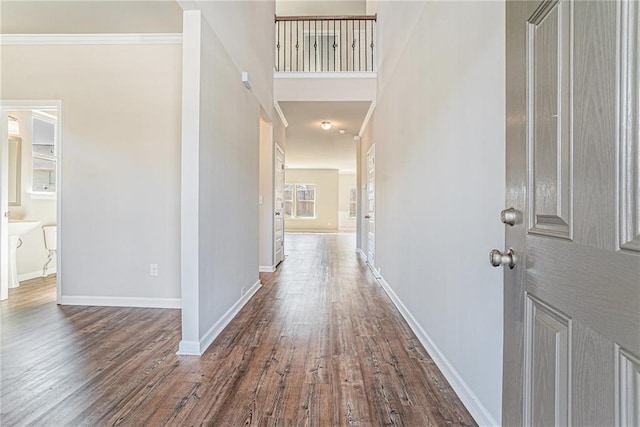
0, 99, 64, 304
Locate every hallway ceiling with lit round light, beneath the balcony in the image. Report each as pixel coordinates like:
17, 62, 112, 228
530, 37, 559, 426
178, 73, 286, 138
279, 101, 371, 173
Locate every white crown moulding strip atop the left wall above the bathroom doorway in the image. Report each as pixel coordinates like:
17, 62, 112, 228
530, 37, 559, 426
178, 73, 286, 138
0, 33, 182, 46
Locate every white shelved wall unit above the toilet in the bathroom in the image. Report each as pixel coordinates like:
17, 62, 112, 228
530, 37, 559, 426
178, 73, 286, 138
31, 116, 56, 193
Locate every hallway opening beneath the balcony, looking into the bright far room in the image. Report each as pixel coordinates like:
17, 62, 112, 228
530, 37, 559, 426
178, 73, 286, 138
279, 101, 364, 260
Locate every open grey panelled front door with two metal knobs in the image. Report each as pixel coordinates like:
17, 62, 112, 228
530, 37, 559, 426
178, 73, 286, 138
504, 0, 640, 426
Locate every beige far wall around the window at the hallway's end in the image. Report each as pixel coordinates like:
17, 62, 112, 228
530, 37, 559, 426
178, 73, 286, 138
285, 169, 338, 231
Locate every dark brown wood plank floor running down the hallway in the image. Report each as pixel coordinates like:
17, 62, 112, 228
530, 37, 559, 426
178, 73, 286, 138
0, 234, 475, 426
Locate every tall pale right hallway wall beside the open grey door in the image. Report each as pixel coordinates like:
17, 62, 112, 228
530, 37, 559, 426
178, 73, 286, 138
360, 2, 505, 425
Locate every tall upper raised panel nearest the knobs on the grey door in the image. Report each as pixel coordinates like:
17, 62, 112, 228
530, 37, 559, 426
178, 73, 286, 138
527, 2, 572, 238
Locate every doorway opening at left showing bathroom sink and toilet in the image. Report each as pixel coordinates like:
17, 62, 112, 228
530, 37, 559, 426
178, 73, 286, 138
0, 101, 62, 302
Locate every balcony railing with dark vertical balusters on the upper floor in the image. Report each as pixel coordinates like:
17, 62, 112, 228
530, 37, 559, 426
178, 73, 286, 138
275, 15, 377, 72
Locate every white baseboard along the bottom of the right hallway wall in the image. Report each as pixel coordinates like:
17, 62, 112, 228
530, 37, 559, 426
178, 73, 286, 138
378, 277, 500, 426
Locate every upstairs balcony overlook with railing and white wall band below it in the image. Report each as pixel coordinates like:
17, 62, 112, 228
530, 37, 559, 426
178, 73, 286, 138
274, 15, 378, 102
